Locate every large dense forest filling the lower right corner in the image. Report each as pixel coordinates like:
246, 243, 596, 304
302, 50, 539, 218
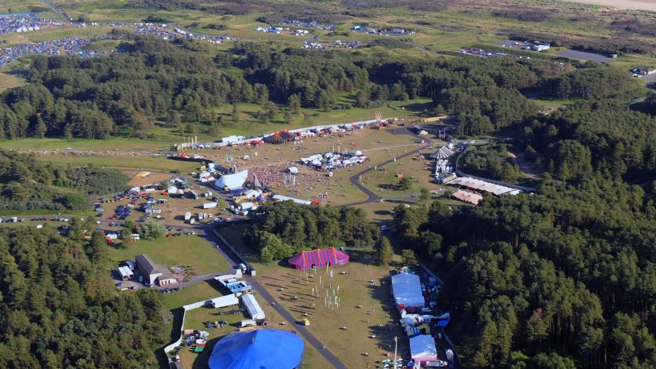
395, 173, 656, 368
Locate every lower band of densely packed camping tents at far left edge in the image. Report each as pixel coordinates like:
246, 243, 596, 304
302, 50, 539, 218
0, 37, 102, 68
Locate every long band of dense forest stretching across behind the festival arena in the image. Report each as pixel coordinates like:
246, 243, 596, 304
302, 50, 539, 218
0, 36, 636, 139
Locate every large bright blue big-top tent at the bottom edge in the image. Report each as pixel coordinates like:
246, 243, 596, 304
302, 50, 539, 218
208, 328, 305, 369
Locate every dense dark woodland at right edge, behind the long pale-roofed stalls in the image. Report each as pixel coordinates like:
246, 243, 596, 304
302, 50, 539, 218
519, 99, 656, 181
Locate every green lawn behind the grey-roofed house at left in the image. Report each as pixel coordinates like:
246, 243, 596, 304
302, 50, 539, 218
110, 235, 230, 275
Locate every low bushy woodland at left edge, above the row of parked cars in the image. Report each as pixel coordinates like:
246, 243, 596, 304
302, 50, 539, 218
0, 150, 129, 211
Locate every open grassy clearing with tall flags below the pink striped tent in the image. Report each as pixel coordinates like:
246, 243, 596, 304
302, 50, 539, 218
256, 258, 408, 368
